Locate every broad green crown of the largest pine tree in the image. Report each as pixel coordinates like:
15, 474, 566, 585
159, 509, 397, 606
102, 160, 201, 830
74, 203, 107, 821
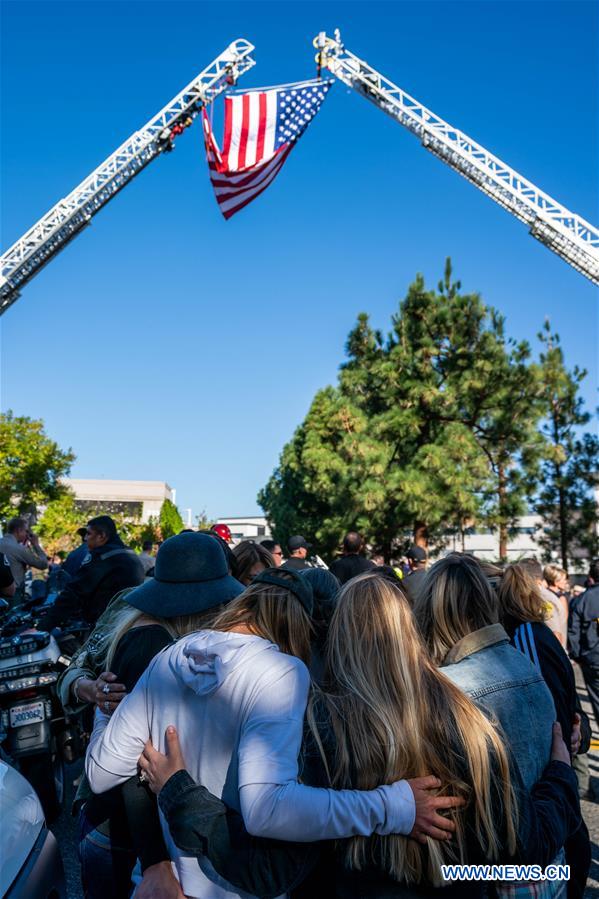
258, 260, 543, 557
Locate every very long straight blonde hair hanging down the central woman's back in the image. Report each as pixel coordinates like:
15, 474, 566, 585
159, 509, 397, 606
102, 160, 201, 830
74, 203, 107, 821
309, 572, 517, 886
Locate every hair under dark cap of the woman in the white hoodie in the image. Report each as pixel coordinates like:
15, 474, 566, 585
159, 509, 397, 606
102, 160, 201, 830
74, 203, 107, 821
212, 568, 312, 664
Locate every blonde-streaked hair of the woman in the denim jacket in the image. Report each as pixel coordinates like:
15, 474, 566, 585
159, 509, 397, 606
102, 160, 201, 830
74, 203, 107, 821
414, 553, 499, 665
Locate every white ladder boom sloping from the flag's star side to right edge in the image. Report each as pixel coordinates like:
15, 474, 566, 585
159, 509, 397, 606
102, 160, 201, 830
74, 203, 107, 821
314, 31, 599, 284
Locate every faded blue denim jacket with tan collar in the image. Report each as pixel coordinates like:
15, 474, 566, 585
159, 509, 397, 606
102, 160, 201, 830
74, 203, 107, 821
442, 624, 555, 790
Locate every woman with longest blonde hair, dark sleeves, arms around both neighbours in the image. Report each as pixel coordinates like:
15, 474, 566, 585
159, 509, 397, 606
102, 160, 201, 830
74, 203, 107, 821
140, 573, 577, 899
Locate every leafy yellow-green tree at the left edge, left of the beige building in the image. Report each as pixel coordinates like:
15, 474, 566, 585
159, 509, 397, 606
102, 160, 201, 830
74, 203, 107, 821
0, 411, 75, 521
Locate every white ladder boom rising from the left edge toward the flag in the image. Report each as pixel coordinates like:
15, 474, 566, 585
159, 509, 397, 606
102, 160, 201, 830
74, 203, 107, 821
0, 39, 255, 315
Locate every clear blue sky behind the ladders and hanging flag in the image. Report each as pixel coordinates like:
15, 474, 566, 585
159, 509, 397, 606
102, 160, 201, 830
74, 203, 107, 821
0, 0, 599, 516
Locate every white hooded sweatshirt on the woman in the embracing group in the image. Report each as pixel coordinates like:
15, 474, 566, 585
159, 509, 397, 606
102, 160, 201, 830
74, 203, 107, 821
86, 631, 415, 899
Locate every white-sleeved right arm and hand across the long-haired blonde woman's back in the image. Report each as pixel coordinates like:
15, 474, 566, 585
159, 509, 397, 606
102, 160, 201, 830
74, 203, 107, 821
238, 659, 461, 842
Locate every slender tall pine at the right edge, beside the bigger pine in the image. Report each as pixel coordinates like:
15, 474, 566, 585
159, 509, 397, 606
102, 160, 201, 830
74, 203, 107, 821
536, 321, 599, 570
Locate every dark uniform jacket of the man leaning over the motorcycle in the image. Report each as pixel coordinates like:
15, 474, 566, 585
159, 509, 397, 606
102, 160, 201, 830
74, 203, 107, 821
39, 537, 144, 630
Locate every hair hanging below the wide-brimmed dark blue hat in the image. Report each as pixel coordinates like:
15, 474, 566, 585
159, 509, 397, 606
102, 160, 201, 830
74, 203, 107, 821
97, 591, 223, 671
